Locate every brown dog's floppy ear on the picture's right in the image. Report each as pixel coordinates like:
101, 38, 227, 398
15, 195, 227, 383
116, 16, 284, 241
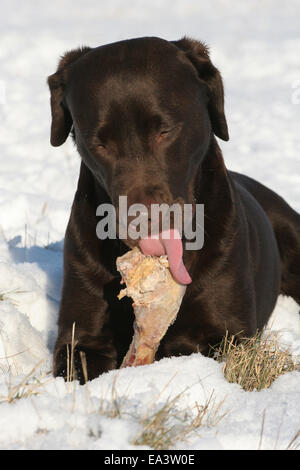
172, 37, 229, 140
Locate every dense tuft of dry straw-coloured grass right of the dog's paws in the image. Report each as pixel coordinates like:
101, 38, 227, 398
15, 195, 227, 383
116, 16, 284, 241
215, 333, 300, 391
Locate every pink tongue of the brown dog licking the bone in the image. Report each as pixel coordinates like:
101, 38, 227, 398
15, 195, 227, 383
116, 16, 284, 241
139, 229, 192, 284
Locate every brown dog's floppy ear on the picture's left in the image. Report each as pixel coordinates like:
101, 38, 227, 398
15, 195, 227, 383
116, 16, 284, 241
48, 47, 91, 147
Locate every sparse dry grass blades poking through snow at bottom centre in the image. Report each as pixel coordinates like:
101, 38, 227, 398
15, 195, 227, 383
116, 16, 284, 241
87, 370, 228, 450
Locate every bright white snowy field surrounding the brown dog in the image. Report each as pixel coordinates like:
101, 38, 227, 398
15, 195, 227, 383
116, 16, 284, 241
0, 0, 300, 450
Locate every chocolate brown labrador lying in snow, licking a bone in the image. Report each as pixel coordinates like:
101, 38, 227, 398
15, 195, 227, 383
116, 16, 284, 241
48, 37, 300, 383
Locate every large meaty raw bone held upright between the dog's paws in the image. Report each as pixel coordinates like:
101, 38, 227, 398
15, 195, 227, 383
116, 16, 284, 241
117, 248, 186, 368
